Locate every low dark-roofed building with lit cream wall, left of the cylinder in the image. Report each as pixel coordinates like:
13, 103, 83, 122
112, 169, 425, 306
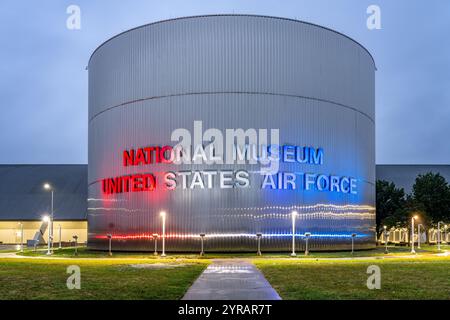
0, 165, 87, 245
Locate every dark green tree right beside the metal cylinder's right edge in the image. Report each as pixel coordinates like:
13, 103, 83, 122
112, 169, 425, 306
376, 180, 407, 237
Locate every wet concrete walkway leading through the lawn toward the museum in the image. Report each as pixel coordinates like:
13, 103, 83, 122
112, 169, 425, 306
183, 259, 281, 300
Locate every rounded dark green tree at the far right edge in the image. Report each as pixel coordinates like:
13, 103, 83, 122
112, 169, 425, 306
412, 172, 450, 225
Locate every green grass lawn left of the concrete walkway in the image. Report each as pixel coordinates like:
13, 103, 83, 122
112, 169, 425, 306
0, 258, 208, 300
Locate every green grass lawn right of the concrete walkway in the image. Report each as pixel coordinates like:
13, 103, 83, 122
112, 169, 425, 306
254, 257, 450, 300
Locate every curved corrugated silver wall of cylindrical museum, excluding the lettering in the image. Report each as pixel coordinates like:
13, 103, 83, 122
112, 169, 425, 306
88, 15, 375, 251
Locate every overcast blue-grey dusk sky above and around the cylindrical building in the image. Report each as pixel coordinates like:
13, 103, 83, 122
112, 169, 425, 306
0, 0, 450, 164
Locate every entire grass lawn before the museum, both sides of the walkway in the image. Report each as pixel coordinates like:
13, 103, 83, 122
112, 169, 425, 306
0, 245, 450, 300
